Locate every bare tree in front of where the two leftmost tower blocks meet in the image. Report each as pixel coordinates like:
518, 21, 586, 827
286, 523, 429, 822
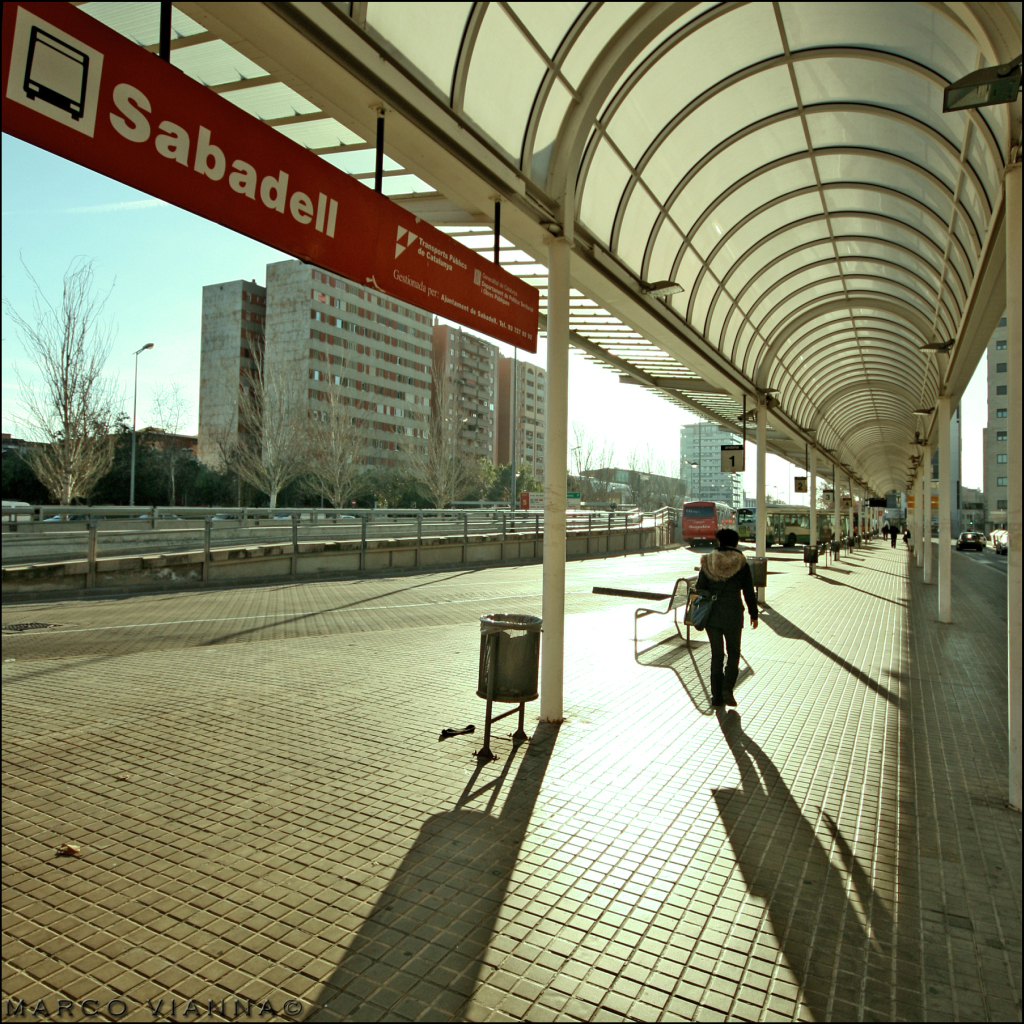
229, 366, 309, 508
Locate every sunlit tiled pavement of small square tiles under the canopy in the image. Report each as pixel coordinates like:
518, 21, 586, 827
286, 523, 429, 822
3, 544, 1021, 1021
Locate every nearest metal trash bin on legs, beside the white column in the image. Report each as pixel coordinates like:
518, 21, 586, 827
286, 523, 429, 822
476, 614, 543, 761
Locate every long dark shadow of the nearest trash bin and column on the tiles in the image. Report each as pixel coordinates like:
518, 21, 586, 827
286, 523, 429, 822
306, 723, 558, 1021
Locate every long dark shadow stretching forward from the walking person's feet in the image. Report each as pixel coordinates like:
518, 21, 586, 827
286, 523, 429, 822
714, 712, 913, 1020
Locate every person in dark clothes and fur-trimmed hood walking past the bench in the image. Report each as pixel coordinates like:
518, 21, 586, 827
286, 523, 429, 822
696, 529, 758, 709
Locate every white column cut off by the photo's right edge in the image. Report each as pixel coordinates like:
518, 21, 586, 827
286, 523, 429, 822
1006, 151, 1024, 811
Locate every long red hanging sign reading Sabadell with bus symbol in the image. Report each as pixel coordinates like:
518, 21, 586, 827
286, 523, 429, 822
3, 3, 539, 352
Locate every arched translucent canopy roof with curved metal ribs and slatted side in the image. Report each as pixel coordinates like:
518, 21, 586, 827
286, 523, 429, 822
83, 2, 1021, 493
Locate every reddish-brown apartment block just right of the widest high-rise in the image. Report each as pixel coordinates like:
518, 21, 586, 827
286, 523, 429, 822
431, 324, 498, 465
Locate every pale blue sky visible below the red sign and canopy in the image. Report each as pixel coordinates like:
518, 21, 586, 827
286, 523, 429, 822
2, 135, 987, 499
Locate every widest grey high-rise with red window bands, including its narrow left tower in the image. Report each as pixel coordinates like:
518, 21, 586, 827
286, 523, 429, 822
199, 260, 432, 466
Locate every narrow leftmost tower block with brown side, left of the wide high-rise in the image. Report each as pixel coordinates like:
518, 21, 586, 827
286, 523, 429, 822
197, 281, 266, 466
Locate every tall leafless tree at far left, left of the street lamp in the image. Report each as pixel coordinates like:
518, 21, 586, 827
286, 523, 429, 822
4, 257, 123, 505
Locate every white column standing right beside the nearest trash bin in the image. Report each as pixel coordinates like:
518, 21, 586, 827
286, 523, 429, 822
541, 239, 570, 722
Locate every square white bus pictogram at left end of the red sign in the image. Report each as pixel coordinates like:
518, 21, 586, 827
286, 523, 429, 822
7, 7, 103, 138
